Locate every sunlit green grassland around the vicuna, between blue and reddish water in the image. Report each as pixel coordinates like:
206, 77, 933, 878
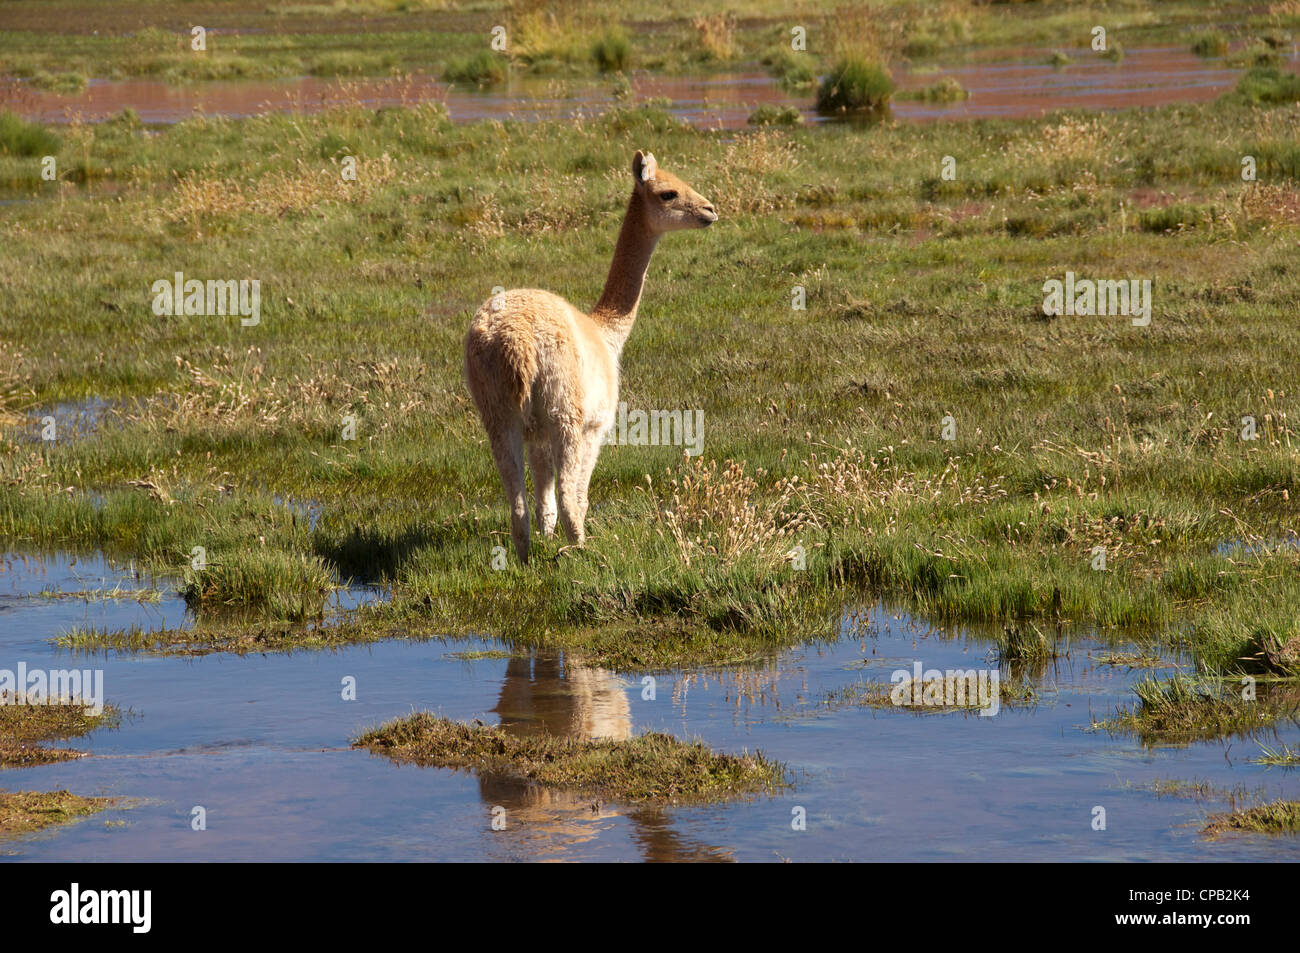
0, 91, 1300, 675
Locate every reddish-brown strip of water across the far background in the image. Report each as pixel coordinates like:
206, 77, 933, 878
0, 48, 1300, 127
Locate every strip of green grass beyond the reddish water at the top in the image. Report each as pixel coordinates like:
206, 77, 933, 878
0, 0, 1300, 87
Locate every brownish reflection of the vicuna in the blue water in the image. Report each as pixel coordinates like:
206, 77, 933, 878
478, 657, 727, 861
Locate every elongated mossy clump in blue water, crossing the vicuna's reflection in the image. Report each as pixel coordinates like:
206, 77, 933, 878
354, 711, 789, 802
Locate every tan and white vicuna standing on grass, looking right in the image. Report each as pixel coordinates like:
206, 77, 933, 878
465, 152, 718, 563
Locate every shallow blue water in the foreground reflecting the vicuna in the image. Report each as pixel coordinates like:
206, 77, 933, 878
0, 546, 1300, 861
